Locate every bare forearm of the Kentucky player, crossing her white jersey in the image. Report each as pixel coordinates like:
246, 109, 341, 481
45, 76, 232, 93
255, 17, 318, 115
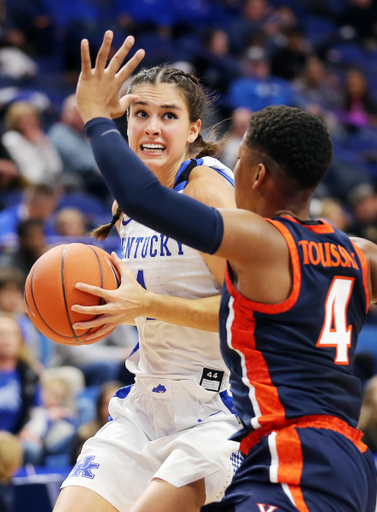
143, 292, 220, 332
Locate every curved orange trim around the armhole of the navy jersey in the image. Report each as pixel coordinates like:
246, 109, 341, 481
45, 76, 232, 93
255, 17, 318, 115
225, 219, 301, 315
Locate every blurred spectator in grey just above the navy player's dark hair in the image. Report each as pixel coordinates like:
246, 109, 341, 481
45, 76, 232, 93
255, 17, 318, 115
293, 55, 343, 107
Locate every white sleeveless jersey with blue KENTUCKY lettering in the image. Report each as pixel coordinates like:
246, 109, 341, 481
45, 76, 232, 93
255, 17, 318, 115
119, 157, 234, 391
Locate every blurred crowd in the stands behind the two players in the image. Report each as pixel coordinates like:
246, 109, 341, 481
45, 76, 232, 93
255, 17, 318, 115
0, 0, 377, 488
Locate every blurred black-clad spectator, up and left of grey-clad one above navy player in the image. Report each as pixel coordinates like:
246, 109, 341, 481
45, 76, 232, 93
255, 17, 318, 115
271, 28, 310, 80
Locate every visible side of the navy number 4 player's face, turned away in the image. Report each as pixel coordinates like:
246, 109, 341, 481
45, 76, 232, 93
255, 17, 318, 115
234, 139, 259, 213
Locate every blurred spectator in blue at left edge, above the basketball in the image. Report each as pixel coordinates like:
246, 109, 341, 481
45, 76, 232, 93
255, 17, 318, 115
0, 183, 58, 246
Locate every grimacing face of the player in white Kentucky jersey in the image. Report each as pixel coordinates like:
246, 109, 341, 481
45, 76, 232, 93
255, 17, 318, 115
127, 84, 200, 186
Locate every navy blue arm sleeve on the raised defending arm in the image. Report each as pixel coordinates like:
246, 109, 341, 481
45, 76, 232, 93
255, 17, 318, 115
85, 118, 224, 254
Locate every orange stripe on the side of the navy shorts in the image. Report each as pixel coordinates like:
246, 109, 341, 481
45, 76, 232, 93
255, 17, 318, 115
275, 426, 309, 512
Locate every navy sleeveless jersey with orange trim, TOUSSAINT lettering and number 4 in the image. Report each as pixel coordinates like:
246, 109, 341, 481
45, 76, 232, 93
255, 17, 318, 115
220, 217, 369, 439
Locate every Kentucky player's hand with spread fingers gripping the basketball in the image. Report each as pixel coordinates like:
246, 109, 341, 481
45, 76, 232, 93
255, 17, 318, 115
72, 252, 147, 341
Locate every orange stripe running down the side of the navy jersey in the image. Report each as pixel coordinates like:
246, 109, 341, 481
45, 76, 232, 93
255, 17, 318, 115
231, 302, 285, 425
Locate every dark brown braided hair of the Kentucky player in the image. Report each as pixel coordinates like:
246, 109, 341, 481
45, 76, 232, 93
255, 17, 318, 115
90, 66, 220, 240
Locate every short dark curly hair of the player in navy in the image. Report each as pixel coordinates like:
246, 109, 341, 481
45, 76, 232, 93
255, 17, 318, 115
245, 105, 333, 193
